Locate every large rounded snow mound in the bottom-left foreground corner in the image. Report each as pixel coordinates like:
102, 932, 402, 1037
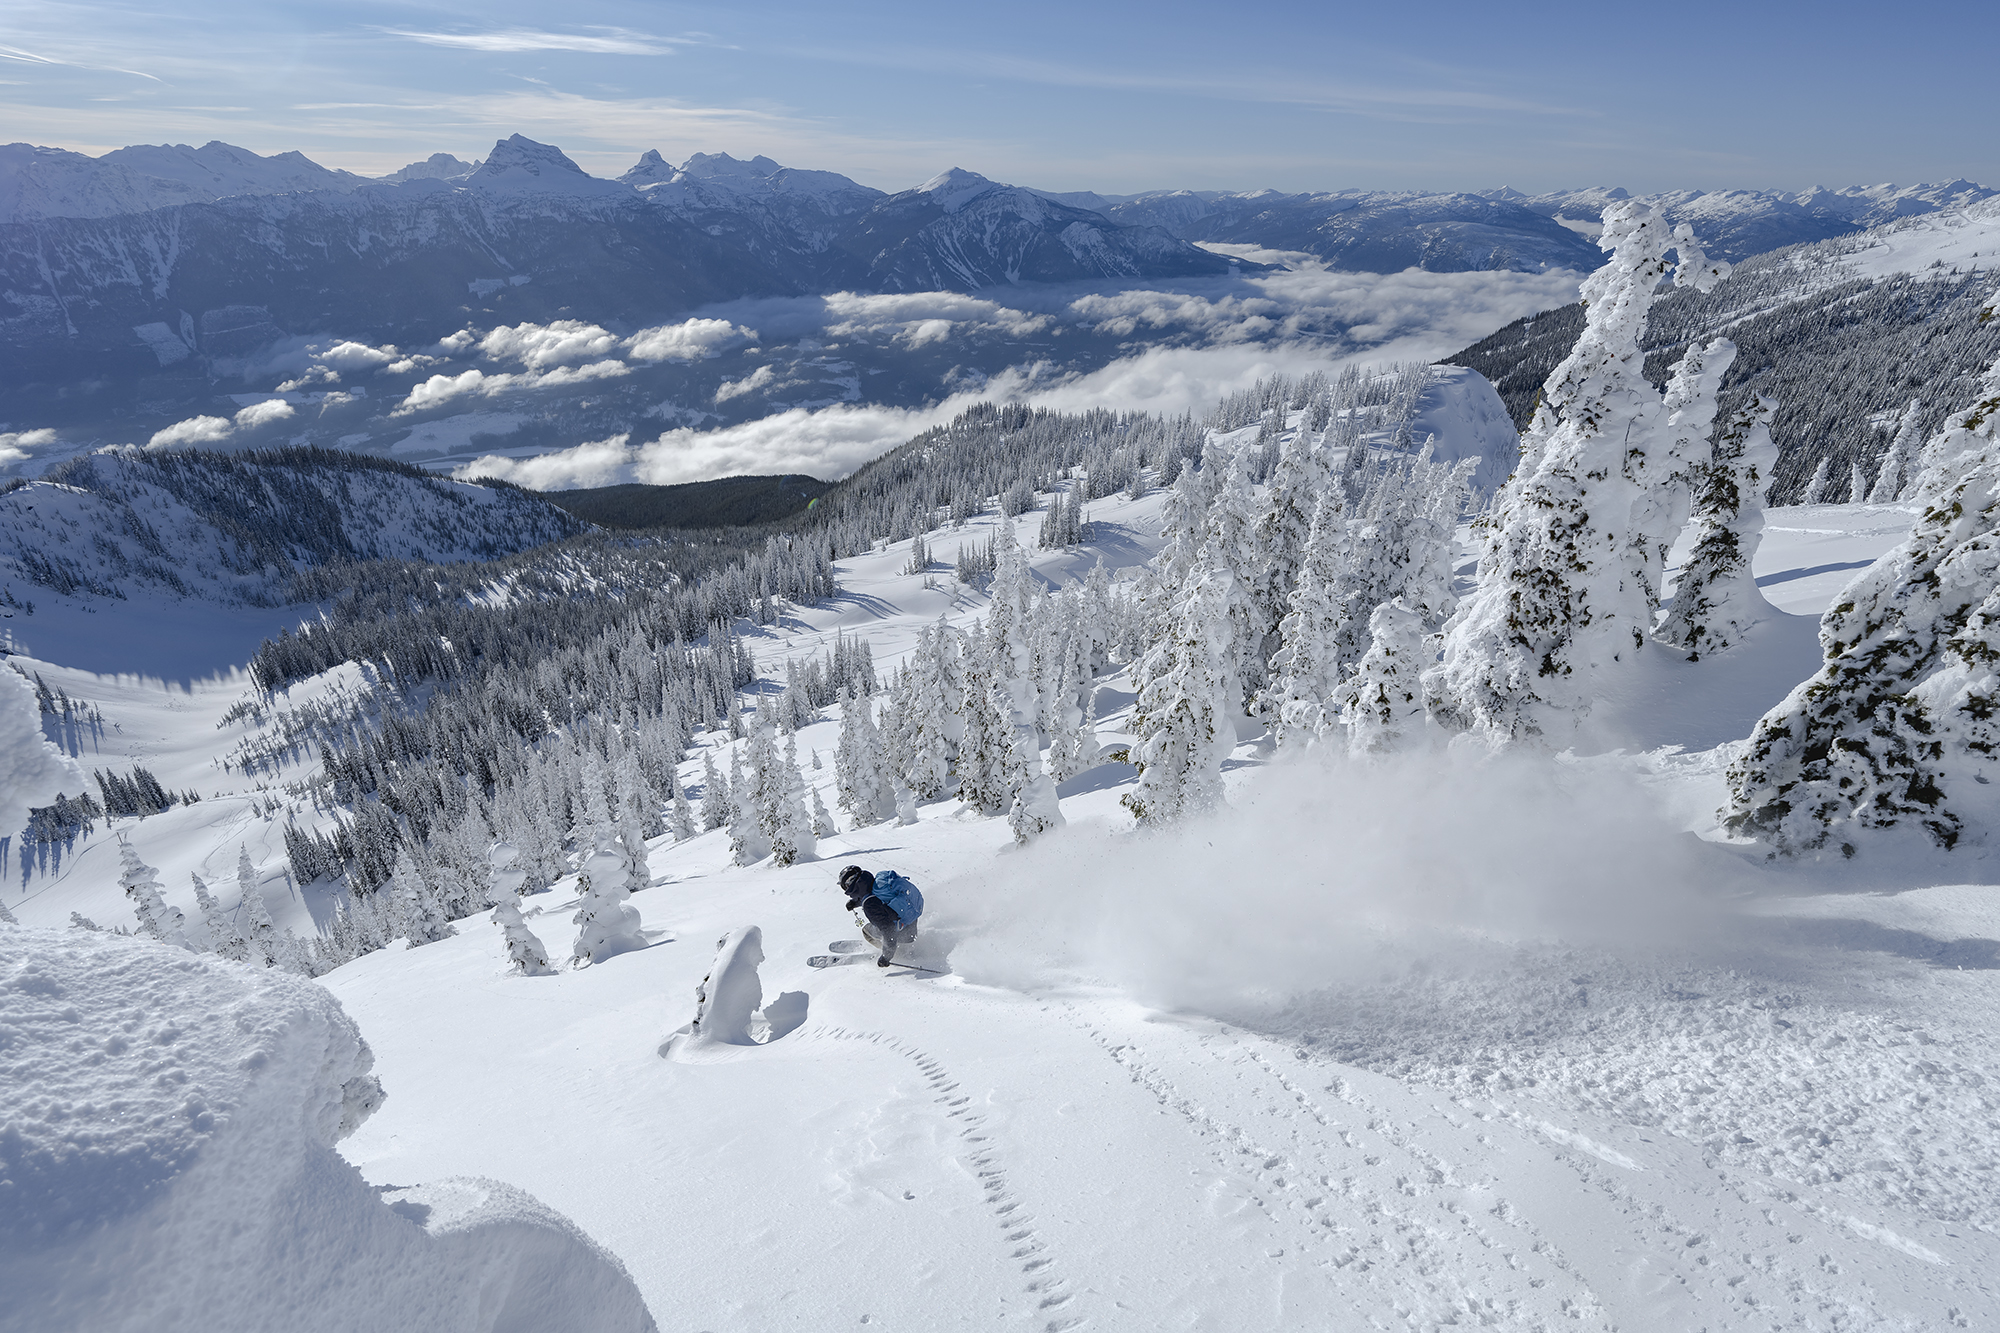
0, 927, 654, 1333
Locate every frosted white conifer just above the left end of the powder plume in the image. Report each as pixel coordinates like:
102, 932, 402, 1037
1122, 550, 1238, 827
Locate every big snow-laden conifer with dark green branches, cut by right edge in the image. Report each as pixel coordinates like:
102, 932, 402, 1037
1724, 326, 2000, 853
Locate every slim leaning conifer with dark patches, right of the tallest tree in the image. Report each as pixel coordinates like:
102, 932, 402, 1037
1658, 398, 1778, 660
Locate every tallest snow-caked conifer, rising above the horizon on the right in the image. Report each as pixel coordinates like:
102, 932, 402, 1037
1426, 200, 1728, 745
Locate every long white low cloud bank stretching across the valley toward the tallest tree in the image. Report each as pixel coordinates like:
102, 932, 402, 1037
458, 264, 1576, 490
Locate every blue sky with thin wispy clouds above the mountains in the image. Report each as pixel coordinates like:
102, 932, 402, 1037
0, 0, 2000, 192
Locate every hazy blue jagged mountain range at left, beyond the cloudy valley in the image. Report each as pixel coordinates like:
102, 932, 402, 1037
0, 134, 1258, 380
